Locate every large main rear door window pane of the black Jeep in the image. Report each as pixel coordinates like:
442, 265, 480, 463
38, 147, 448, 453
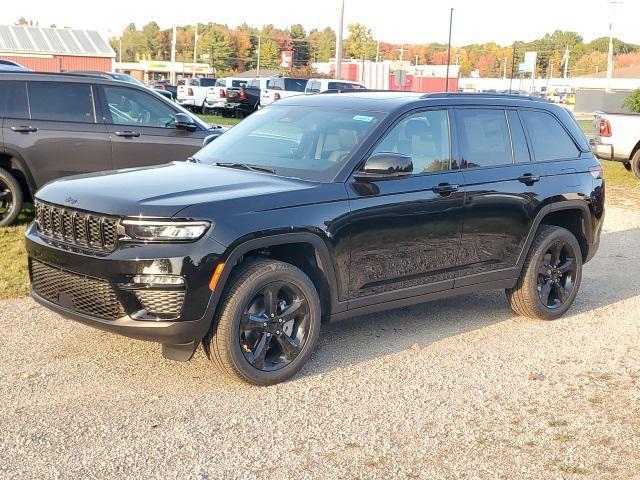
456, 108, 513, 168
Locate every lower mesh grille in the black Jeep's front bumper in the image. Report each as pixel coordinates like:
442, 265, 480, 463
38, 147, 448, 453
31, 260, 125, 320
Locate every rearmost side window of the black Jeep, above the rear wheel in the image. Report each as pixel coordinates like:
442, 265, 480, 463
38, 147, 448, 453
520, 110, 579, 162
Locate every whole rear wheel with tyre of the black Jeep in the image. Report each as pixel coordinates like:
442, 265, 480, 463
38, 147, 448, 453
506, 225, 582, 320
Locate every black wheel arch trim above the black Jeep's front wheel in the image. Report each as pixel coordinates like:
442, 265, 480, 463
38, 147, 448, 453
209, 232, 347, 314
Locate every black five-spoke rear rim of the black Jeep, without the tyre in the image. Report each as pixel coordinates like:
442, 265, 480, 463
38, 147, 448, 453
538, 239, 578, 309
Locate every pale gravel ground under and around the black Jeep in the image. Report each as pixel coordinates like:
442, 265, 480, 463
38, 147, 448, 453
0, 204, 640, 480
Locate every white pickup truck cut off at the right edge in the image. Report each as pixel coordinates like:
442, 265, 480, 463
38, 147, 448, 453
591, 112, 640, 178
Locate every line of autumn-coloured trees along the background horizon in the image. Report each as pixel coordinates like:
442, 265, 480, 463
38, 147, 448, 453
110, 22, 640, 77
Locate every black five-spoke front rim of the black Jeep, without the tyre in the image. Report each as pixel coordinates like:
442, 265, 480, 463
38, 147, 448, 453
239, 282, 310, 372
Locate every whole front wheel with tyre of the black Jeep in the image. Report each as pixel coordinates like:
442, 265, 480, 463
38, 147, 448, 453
205, 259, 321, 385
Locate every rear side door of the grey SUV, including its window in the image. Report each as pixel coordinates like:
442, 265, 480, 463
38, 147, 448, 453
3, 81, 111, 188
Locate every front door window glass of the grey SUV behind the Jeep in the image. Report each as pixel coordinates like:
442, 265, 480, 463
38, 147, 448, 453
103, 87, 175, 128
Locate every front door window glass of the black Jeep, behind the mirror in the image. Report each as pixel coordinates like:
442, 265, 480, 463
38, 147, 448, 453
374, 110, 450, 174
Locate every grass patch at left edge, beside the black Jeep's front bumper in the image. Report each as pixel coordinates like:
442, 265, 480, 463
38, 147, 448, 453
0, 205, 33, 299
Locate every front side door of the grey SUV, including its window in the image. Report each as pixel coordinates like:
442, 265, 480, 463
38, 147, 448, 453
100, 85, 207, 169
